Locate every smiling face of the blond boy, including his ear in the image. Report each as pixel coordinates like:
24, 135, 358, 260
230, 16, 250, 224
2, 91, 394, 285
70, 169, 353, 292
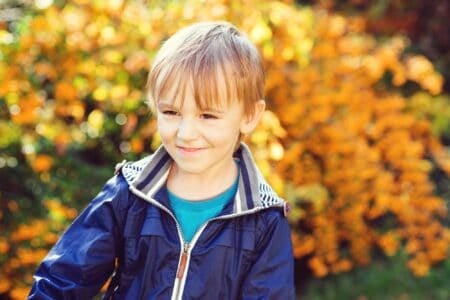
156, 83, 259, 178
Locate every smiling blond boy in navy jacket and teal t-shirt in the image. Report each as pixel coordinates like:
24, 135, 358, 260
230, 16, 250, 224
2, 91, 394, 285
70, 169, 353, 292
29, 22, 294, 300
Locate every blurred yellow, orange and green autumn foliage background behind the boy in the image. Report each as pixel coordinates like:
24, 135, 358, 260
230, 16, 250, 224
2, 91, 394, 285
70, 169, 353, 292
0, 0, 450, 300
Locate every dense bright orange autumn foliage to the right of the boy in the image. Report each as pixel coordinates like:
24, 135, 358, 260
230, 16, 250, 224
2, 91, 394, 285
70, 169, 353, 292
256, 4, 450, 277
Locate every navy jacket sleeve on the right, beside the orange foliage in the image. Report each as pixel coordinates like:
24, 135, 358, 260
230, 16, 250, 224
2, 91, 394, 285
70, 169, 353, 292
242, 211, 295, 300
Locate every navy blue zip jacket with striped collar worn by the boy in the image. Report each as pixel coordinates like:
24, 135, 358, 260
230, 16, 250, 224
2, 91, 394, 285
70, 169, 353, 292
29, 144, 295, 300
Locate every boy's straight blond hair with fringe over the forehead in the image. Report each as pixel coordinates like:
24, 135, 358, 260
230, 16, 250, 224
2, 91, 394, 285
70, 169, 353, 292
147, 22, 265, 114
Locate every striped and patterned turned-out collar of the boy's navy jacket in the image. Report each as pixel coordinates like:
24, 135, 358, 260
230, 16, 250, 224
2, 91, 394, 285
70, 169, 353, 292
118, 143, 286, 215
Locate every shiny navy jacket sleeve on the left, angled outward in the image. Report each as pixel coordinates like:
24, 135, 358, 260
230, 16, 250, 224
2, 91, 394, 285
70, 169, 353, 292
28, 175, 128, 299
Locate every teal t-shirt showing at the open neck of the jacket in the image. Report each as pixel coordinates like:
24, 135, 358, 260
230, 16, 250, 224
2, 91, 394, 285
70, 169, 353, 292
167, 177, 239, 242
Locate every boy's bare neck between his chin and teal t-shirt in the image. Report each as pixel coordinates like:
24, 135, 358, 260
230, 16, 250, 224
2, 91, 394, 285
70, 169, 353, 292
166, 161, 238, 201
